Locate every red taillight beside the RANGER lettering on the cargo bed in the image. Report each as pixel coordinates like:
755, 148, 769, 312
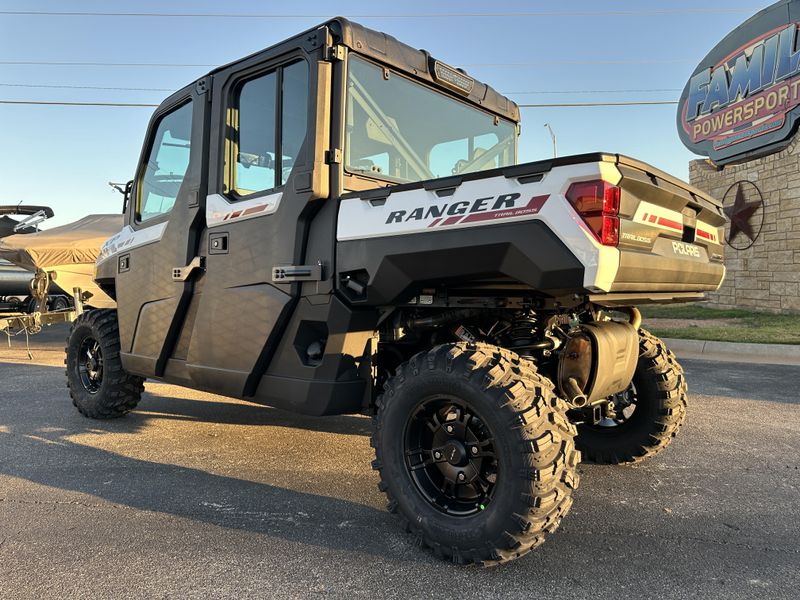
567, 179, 620, 246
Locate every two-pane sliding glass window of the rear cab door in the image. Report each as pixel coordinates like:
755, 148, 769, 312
226, 61, 308, 196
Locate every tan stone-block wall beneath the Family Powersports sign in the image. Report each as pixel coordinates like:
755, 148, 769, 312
689, 137, 800, 313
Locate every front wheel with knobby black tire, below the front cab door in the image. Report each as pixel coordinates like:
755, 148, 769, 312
64, 309, 144, 419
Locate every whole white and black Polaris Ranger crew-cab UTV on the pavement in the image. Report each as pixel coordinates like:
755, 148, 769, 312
66, 18, 725, 564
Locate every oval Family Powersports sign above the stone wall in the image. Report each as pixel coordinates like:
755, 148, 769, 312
678, 0, 800, 166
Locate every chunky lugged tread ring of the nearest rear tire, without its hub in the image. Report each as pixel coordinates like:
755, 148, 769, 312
371, 343, 580, 566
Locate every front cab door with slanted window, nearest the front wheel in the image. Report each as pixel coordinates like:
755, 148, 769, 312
116, 79, 208, 377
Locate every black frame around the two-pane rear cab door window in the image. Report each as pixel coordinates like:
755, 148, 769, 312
227, 54, 313, 202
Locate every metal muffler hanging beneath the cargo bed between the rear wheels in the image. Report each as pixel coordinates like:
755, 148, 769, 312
558, 321, 639, 408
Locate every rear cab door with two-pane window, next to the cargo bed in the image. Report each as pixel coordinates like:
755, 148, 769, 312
177, 44, 330, 397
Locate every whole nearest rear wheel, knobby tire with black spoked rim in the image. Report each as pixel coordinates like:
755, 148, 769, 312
372, 343, 580, 566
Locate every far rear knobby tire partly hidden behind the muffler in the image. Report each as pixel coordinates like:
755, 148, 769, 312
576, 329, 688, 464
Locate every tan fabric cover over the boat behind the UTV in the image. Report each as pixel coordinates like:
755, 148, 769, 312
0, 215, 123, 271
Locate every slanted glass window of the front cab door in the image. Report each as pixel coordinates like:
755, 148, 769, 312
136, 102, 192, 223
